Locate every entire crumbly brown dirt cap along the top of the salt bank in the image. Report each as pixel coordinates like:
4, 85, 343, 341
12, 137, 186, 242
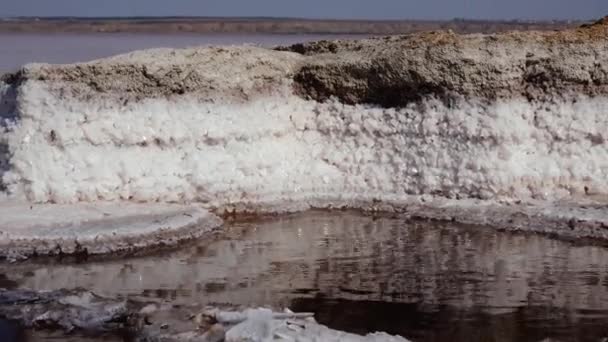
4, 18, 608, 107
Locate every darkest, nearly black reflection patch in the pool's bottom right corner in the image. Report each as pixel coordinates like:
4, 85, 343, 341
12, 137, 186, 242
292, 298, 608, 342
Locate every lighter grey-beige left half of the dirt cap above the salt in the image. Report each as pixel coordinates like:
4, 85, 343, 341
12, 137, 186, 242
4, 46, 300, 104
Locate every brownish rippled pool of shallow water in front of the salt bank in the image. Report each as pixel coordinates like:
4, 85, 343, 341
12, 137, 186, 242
0, 212, 608, 341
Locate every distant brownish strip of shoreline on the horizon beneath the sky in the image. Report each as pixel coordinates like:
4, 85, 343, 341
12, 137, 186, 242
0, 17, 585, 35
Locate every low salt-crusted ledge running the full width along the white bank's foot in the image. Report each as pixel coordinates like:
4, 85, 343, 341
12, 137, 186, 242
5, 198, 608, 261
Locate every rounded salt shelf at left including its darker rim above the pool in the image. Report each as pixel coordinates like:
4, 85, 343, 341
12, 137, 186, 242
0, 201, 221, 258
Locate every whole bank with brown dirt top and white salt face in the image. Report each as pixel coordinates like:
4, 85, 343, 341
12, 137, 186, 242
0, 19, 608, 250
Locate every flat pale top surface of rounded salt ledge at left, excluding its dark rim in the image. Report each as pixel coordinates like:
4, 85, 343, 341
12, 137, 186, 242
0, 203, 220, 241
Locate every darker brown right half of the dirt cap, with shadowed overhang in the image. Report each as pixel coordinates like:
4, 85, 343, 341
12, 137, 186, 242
279, 18, 608, 107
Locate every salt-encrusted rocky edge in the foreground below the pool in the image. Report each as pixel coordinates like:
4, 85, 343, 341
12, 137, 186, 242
0, 289, 408, 342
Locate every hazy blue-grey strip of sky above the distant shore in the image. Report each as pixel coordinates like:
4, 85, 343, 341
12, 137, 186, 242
0, 0, 608, 19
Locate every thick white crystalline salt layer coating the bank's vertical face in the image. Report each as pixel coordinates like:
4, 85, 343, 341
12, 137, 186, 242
3, 80, 608, 208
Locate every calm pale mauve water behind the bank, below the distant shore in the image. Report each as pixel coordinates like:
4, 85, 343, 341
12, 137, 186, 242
0, 33, 363, 74
